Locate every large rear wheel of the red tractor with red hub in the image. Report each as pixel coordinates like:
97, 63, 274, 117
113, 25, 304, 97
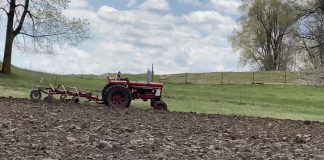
106, 86, 131, 108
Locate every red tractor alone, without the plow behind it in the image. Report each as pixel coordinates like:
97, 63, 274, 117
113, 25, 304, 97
102, 78, 167, 110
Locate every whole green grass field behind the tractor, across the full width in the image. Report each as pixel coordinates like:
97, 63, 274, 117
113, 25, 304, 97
0, 62, 324, 121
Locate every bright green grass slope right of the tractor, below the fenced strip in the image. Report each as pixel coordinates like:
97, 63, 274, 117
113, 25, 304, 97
165, 84, 324, 121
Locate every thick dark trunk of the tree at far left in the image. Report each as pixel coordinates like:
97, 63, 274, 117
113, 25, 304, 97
1, 0, 16, 74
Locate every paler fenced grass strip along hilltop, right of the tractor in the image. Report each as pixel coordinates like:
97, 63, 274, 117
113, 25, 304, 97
159, 71, 324, 85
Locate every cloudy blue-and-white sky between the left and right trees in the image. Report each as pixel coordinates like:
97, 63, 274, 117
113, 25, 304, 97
0, 0, 249, 74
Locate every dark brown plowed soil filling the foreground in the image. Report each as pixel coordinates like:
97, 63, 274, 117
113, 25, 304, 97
0, 98, 324, 160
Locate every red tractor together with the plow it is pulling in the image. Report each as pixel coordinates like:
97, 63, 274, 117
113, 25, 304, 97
30, 77, 167, 110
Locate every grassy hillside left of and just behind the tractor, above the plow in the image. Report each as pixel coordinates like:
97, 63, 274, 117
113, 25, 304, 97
0, 62, 145, 91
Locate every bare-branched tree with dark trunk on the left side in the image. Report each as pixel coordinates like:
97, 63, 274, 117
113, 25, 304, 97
0, 0, 89, 74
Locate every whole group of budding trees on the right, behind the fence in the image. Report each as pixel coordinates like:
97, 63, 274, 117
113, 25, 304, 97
230, 0, 324, 71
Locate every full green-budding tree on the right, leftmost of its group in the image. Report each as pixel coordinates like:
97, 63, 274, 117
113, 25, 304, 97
230, 0, 297, 71
